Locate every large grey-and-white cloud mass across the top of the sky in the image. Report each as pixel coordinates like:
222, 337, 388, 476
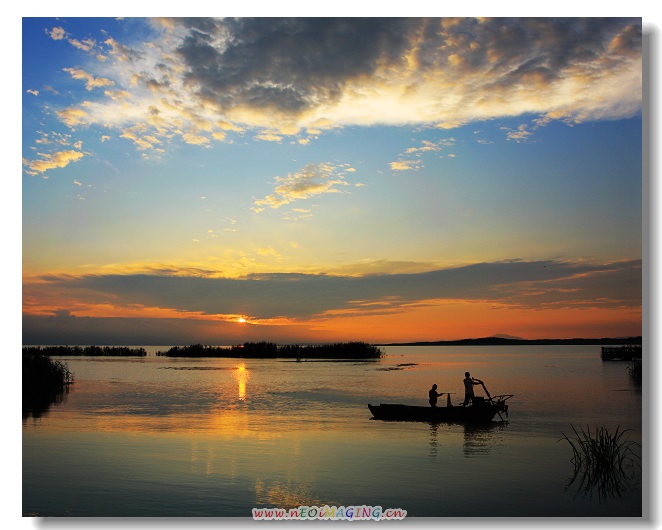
42, 18, 641, 145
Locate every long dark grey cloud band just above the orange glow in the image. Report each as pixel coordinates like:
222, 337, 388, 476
36, 260, 641, 320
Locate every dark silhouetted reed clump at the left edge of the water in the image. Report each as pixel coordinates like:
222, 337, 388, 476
23, 354, 74, 419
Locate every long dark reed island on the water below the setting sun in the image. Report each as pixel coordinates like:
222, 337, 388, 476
156, 342, 383, 360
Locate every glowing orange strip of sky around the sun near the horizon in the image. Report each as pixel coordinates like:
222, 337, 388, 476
24, 272, 642, 345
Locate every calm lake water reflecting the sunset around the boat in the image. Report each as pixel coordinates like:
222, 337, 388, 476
22, 346, 648, 518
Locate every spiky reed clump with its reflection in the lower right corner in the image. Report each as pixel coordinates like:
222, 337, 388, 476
561, 425, 641, 500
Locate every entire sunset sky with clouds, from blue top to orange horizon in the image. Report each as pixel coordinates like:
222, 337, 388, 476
22, 17, 642, 345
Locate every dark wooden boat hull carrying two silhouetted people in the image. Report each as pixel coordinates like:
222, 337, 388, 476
368, 402, 508, 423
